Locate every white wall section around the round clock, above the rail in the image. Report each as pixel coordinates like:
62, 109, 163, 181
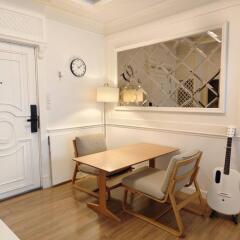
46, 20, 105, 129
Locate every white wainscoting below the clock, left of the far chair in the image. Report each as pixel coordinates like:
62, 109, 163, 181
48, 124, 102, 185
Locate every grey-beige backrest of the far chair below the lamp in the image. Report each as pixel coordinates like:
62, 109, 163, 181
73, 134, 107, 157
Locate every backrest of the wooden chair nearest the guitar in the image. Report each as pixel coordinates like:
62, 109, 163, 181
161, 151, 202, 193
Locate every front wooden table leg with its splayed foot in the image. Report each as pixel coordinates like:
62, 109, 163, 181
87, 171, 121, 222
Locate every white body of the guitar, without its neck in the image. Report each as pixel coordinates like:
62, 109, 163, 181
207, 167, 240, 215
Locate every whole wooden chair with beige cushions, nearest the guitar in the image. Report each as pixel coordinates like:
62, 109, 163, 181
122, 151, 204, 237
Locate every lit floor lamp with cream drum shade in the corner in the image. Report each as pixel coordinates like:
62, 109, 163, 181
97, 84, 119, 138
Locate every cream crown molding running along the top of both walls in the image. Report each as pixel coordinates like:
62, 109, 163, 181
24, 0, 240, 36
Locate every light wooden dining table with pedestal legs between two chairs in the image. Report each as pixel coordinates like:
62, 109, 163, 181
73, 143, 178, 221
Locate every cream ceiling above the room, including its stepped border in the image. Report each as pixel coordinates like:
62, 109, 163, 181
34, 0, 220, 34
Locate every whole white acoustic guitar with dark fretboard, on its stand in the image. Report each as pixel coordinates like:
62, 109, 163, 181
207, 127, 240, 224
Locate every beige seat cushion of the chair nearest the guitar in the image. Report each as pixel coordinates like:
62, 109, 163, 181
122, 167, 166, 199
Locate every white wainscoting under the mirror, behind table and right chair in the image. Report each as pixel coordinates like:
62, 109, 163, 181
107, 125, 240, 193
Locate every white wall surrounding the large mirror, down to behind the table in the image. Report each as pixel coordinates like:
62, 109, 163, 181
106, 2, 240, 191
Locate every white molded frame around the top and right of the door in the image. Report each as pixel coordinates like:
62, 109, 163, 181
0, 3, 52, 188
